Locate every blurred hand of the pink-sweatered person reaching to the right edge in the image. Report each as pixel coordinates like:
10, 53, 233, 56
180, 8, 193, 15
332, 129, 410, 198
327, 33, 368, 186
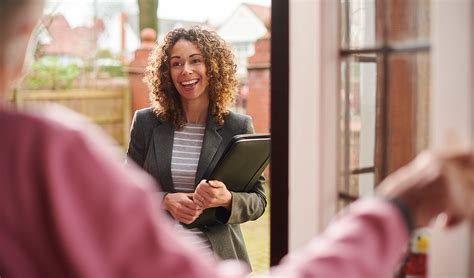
378, 151, 474, 227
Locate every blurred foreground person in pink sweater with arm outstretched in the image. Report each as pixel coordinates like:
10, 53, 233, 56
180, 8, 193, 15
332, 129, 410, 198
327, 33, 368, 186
0, 0, 474, 277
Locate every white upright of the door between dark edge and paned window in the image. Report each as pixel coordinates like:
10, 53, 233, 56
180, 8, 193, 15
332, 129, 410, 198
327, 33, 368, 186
288, 0, 339, 251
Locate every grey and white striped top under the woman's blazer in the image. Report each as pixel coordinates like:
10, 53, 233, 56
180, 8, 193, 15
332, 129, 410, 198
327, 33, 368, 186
171, 123, 214, 257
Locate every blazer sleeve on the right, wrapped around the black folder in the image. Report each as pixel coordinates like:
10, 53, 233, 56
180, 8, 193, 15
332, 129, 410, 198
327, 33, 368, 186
223, 117, 267, 224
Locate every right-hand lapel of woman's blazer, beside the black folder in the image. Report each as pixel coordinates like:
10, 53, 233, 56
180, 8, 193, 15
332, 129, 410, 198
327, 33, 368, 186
194, 115, 222, 185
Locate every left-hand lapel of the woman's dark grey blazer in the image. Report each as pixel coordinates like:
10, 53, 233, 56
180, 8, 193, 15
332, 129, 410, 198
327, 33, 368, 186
153, 122, 174, 191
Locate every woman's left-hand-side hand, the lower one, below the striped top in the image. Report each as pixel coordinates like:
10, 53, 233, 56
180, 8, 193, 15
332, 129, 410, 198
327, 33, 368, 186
162, 193, 202, 224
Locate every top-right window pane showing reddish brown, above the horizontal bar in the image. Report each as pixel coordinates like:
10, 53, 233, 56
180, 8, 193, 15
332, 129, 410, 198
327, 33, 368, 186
385, 0, 430, 43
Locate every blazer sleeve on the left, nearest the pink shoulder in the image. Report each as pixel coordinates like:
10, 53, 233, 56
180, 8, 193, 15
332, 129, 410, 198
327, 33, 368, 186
127, 111, 145, 167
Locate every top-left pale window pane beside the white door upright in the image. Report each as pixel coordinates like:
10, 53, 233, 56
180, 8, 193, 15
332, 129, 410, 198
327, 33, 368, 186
341, 0, 376, 48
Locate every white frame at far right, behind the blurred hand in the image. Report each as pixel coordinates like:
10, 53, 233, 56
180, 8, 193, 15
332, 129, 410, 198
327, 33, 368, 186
428, 0, 474, 277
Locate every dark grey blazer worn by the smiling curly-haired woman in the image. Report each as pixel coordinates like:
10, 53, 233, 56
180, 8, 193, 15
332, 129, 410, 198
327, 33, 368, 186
127, 108, 267, 266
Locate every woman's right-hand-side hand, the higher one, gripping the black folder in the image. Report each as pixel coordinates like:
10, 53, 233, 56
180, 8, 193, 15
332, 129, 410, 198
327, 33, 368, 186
193, 180, 232, 210
